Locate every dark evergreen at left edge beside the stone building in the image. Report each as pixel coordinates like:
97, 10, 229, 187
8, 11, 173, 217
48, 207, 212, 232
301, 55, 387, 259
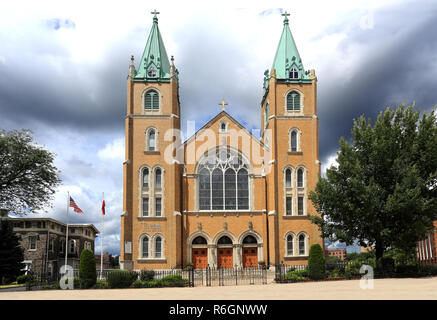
0, 218, 24, 284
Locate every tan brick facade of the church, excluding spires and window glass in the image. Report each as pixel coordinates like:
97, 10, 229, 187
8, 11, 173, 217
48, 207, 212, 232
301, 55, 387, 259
120, 15, 324, 270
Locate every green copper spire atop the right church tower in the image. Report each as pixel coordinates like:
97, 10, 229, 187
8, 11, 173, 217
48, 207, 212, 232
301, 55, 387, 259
272, 11, 309, 81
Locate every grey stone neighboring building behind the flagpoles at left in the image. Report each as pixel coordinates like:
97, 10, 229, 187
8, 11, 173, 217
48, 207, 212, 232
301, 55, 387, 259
9, 218, 99, 274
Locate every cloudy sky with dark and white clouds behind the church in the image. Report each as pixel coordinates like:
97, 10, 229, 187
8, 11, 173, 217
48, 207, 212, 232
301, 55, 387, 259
0, 0, 437, 254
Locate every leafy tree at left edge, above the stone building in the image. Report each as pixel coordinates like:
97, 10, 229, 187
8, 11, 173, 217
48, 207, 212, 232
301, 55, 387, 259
0, 130, 61, 214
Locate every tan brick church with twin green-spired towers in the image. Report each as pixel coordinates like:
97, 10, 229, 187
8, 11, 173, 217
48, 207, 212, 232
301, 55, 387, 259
120, 11, 324, 270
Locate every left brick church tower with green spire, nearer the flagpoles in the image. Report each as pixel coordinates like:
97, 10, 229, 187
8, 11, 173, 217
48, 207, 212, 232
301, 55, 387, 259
120, 10, 181, 270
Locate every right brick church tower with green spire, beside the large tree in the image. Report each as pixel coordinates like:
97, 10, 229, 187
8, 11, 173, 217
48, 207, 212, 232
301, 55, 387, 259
261, 12, 323, 265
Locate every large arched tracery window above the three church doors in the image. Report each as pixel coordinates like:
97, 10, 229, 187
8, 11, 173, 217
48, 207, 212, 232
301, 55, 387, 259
198, 150, 249, 210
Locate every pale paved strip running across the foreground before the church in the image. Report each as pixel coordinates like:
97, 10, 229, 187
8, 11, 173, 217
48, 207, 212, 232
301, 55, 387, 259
0, 277, 437, 300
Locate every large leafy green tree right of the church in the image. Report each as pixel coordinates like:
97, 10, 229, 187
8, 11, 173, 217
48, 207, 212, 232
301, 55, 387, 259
309, 105, 437, 270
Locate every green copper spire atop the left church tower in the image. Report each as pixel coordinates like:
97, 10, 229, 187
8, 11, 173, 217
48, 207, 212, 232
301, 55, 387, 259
135, 10, 170, 81
